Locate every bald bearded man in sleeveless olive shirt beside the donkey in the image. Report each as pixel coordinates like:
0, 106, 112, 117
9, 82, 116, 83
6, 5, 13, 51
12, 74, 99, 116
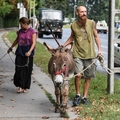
63, 6, 102, 106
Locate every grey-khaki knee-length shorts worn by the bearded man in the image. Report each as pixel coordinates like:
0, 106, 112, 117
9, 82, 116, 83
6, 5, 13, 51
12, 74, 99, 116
74, 58, 97, 78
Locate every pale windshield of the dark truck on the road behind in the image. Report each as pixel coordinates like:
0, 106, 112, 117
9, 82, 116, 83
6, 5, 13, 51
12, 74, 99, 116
42, 10, 62, 20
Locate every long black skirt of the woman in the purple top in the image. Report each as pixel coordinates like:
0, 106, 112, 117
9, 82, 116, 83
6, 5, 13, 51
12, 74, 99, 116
14, 55, 33, 89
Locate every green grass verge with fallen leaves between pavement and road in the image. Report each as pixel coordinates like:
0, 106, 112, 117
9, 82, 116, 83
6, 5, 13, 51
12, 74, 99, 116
4, 31, 120, 120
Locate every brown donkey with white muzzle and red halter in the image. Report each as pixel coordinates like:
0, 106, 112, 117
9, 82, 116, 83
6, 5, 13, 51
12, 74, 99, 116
43, 42, 74, 117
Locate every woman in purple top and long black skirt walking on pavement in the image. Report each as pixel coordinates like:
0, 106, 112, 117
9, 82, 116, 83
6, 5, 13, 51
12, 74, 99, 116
8, 17, 37, 93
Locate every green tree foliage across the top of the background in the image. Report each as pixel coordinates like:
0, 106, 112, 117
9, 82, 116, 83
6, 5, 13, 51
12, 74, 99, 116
0, 0, 114, 26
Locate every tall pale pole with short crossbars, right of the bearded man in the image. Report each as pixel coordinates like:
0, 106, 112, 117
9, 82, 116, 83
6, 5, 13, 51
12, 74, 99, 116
107, 0, 120, 94
